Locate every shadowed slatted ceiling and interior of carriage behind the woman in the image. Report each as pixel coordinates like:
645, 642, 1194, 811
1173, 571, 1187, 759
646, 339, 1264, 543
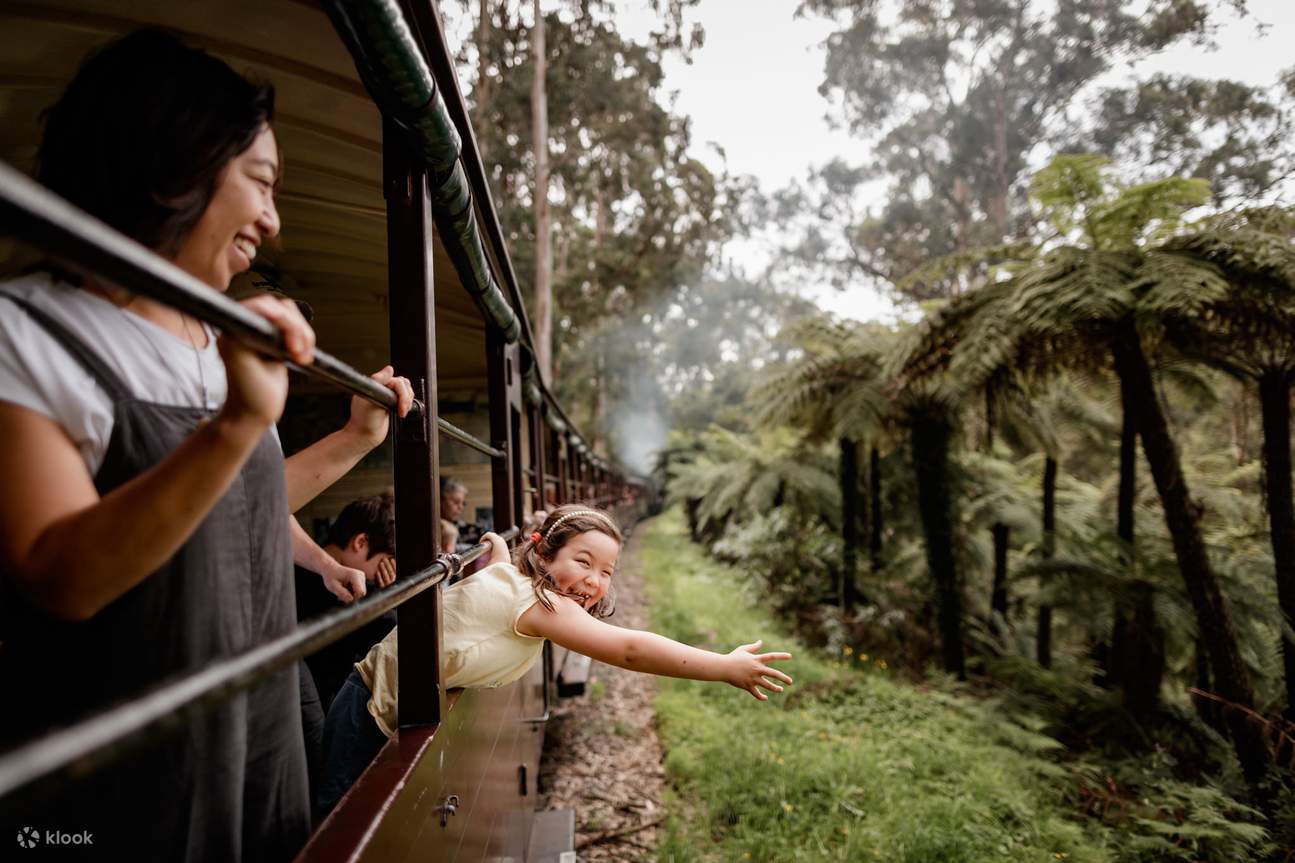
0, 0, 502, 531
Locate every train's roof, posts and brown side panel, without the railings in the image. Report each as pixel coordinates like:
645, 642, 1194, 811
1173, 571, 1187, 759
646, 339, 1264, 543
0, 0, 635, 860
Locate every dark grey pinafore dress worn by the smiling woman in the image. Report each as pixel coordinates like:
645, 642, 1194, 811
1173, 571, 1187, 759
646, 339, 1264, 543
0, 294, 310, 863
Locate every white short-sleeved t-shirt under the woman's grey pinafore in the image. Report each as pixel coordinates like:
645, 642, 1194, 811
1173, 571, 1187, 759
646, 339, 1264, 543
0, 272, 227, 476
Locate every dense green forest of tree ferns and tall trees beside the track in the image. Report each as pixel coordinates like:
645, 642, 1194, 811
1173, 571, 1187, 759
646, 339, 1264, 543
445, 0, 1295, 860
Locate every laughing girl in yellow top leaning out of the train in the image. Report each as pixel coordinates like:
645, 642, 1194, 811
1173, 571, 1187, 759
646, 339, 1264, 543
317, 504, 791, 812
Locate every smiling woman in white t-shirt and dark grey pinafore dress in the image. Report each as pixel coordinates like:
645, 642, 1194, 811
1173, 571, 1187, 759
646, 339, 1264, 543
0, 31, 412, 860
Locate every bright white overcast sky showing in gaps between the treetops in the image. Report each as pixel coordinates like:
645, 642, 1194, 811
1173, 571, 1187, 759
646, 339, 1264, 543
616, 0, 1295, 319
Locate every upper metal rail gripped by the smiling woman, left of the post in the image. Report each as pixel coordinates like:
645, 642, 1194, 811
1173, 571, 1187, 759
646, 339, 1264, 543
0, 161, 396, 408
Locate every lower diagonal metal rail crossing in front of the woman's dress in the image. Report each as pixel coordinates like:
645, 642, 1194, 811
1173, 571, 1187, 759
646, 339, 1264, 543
0, 527, 518, 798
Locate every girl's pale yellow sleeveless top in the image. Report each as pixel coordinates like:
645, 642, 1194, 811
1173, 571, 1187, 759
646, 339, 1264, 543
355, 564, 544, 737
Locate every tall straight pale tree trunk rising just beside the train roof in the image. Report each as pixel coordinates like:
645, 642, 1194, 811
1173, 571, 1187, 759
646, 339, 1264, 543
531, 0, 553, 386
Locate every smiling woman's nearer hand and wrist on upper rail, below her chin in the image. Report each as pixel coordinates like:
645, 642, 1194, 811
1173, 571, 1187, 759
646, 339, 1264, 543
218, 294, 315, 426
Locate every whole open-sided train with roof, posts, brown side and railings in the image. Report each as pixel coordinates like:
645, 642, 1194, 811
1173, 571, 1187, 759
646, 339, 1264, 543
0, 0, 644, 863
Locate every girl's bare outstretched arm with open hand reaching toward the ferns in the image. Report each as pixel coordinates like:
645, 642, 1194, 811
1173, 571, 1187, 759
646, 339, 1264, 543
517, 596, 791, 701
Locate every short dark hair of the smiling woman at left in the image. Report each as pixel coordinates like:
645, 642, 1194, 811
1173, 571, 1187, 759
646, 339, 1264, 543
36, 30, 275, 254
